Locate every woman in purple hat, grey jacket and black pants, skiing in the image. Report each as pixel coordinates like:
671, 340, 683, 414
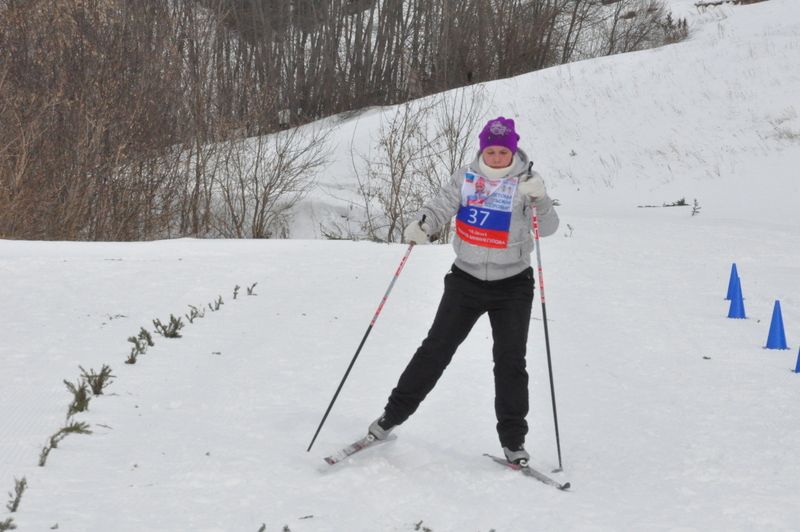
369, 116, 558, 464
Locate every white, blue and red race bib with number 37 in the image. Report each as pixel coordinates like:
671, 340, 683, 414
456, 172, 519, 248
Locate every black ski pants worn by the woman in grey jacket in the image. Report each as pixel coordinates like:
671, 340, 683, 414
386, 265, 534, 447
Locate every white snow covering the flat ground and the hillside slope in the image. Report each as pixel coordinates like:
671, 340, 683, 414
0, 0, 800, 532
